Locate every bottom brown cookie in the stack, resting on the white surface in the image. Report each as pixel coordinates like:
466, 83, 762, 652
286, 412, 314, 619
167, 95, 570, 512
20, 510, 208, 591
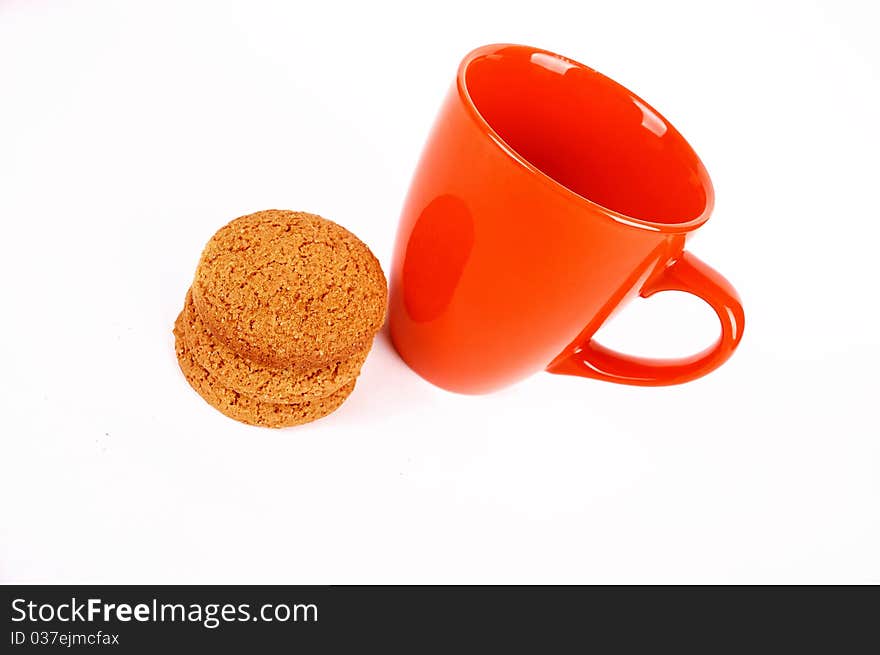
174, 312, 355, 428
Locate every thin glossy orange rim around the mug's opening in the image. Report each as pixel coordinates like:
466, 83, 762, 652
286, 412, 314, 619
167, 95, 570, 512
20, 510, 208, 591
456, 43, 715, 234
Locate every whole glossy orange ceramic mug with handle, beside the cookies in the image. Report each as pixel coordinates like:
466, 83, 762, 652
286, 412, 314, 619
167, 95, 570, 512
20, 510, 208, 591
389, 45, 744, 393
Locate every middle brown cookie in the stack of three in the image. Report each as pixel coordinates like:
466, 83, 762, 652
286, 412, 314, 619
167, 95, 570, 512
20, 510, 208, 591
183, 292, 370, 403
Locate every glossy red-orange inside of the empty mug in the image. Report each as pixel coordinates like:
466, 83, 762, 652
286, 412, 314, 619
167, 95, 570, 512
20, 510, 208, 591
462, 46, 712, 224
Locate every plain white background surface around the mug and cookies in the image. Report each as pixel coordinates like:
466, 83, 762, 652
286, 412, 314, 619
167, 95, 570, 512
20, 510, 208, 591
0, 0, 880, 583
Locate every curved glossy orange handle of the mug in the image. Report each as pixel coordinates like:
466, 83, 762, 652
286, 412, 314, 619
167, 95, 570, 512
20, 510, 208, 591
547, 251, 745, 387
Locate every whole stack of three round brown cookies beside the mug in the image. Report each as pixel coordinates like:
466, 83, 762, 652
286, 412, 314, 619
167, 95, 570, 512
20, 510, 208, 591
174, 210, 387, 428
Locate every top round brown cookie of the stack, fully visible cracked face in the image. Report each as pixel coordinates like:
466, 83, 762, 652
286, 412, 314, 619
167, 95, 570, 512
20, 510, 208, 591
192, 209, 387, 371
